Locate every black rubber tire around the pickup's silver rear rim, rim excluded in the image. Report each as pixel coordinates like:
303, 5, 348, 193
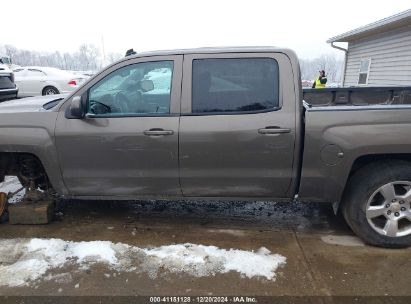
341, 160, 411, 248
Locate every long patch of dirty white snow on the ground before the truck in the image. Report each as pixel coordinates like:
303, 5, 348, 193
0, 238, 286, 287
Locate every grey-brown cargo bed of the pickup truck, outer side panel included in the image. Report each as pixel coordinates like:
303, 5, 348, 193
299, 87, 411, 202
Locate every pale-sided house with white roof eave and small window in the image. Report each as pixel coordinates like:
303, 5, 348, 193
327, 9, 411, 87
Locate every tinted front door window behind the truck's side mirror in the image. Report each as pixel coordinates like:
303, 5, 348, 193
87, 61, 173, 116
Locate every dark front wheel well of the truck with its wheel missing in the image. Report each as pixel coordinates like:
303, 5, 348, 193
0, 152, 51, 189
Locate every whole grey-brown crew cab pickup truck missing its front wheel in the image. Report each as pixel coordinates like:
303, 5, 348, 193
0, 48, 411, 247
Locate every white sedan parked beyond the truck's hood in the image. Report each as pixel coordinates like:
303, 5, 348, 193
14, 66, 86, 97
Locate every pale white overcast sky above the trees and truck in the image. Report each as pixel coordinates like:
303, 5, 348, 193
0, 0, 411, 58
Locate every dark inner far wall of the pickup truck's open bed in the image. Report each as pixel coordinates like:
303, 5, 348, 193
303, 86, 411, 107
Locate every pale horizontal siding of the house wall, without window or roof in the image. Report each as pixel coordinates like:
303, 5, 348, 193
344, 25, 411, 87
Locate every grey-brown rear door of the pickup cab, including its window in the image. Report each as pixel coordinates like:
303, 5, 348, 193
179, 53, 296, 198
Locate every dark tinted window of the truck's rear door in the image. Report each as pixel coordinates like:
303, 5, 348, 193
192, 58, 279, 114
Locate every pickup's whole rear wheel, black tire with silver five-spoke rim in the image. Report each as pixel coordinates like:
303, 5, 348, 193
342, 161, 411, 248
